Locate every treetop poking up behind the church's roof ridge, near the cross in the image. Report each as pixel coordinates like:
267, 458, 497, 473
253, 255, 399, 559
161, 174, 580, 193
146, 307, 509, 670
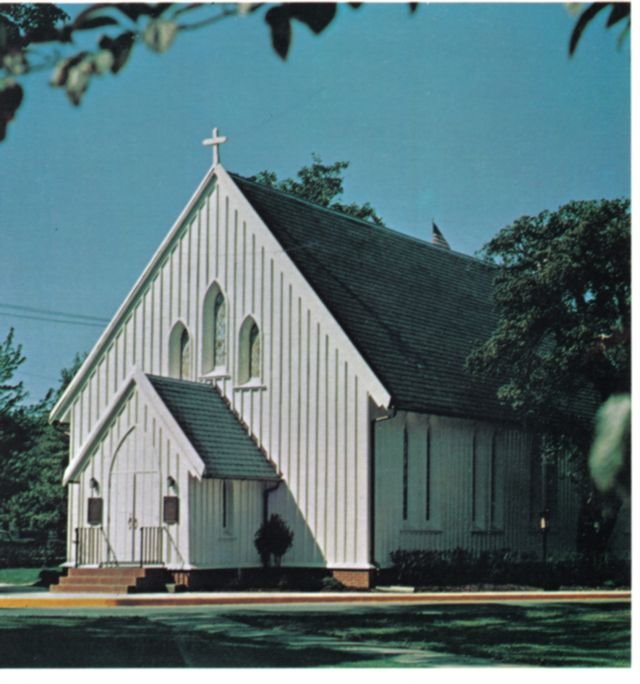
250, 154, 383, 225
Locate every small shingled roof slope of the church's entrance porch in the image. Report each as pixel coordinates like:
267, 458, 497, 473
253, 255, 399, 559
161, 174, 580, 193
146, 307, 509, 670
147, 375, 279, 480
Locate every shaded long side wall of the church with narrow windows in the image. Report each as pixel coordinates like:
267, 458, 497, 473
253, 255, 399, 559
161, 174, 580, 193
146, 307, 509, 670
375, 412, 556, 567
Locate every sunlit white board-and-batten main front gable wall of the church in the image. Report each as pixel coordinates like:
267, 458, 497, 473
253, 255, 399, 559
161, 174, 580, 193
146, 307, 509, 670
63, 168, 389, 568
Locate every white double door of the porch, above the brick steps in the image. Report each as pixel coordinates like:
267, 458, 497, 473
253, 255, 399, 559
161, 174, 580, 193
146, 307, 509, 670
108, 471, 161, 564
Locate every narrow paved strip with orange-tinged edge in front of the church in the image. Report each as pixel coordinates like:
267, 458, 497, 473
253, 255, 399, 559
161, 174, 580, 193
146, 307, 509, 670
0, 587, 631, 609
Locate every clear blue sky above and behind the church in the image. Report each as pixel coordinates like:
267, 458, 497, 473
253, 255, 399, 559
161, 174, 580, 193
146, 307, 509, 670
0, 3, 631, 400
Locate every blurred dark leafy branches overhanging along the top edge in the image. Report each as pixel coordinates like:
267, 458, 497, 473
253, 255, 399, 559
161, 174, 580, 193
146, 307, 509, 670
0, 2, 631, 141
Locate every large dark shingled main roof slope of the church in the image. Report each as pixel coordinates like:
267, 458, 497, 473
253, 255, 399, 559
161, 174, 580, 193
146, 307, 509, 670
232, 174, 508, 419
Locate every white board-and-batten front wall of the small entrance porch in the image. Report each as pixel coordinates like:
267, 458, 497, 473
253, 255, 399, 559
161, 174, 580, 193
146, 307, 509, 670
68, 386, 191, 568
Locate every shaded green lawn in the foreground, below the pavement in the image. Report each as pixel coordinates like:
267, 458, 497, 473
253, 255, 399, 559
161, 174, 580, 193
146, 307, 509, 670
0, 602, 631, 667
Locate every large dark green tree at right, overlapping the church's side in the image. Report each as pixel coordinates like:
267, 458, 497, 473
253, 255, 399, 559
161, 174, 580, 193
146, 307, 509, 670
468, 199, 631, 550
